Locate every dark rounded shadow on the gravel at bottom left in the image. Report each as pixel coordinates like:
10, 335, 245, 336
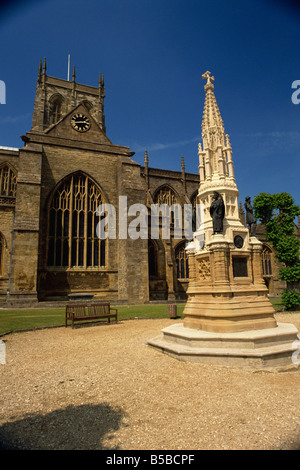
0, 403, 125, 450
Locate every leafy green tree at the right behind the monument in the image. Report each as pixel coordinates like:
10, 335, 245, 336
253, 192, 300, 309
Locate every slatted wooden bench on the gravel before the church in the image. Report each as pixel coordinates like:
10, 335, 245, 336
66, 302, 118, 328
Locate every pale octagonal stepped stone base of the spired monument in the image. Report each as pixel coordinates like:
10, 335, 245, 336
148, 323, 299, 369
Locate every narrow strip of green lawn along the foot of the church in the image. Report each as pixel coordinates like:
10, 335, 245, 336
0, 298, 288, 334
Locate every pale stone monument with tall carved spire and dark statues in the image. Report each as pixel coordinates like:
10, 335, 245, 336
148, 72, 298, 369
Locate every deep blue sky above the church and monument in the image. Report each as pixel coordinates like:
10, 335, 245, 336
0, 0, 300, 204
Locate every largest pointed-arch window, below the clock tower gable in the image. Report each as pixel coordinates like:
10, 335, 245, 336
48, 173, 105, 268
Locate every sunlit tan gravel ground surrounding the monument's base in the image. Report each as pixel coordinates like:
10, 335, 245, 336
0, 314, 300, 450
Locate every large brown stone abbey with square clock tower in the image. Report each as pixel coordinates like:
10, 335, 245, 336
0, 60, 296, 305
